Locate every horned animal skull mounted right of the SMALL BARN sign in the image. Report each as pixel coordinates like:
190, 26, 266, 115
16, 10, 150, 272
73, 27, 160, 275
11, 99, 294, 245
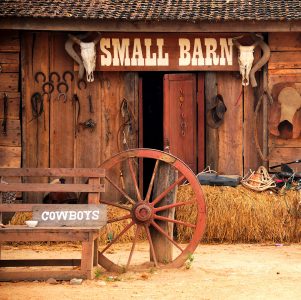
232, 34, 270, 87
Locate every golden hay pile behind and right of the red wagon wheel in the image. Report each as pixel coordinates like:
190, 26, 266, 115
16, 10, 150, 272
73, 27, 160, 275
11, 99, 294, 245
176, 185, 301, 243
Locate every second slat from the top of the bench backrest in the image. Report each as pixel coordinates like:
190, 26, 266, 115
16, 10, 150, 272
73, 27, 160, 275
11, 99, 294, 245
0, 183, 104, 193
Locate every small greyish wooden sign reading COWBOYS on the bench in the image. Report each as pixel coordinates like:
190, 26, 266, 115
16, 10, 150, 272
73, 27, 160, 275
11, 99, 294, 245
32, 204, 107, 227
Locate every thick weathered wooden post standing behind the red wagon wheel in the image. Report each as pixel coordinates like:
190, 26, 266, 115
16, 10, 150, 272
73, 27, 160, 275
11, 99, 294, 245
150, 162, 178, 264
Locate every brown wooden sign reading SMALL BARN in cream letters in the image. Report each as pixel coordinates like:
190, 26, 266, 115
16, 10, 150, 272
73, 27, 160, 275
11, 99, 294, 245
96, 33, 239, 71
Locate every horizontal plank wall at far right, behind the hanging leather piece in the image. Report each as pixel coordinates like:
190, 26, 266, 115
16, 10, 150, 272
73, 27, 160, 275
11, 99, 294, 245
268, 33, 301, 172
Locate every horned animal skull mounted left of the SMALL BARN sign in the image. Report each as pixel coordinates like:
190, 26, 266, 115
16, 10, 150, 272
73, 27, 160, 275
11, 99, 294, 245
65, 33, 100, 82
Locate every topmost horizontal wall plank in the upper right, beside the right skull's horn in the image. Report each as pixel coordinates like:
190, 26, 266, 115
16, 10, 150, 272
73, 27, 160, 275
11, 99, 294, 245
269, 32, 301, 51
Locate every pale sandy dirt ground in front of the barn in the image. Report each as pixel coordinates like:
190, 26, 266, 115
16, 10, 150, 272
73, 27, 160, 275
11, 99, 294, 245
0, 243, 301, 300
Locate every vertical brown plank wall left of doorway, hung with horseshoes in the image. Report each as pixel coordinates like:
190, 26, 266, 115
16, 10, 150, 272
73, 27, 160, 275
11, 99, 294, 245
22, 32, 139, 192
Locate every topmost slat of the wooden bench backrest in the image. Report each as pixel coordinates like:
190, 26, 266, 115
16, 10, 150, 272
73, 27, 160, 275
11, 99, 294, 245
0, 168, 105, 177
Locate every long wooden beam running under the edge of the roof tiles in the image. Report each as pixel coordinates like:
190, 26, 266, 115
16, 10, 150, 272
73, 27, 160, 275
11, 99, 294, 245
0, 17, 301, 32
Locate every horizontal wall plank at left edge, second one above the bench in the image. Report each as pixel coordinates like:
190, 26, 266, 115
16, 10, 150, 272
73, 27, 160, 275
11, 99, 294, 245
0, 119, 21, 147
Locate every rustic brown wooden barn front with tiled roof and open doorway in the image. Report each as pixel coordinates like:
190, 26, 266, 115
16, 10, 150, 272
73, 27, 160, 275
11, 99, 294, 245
0, 1, 301, 175
